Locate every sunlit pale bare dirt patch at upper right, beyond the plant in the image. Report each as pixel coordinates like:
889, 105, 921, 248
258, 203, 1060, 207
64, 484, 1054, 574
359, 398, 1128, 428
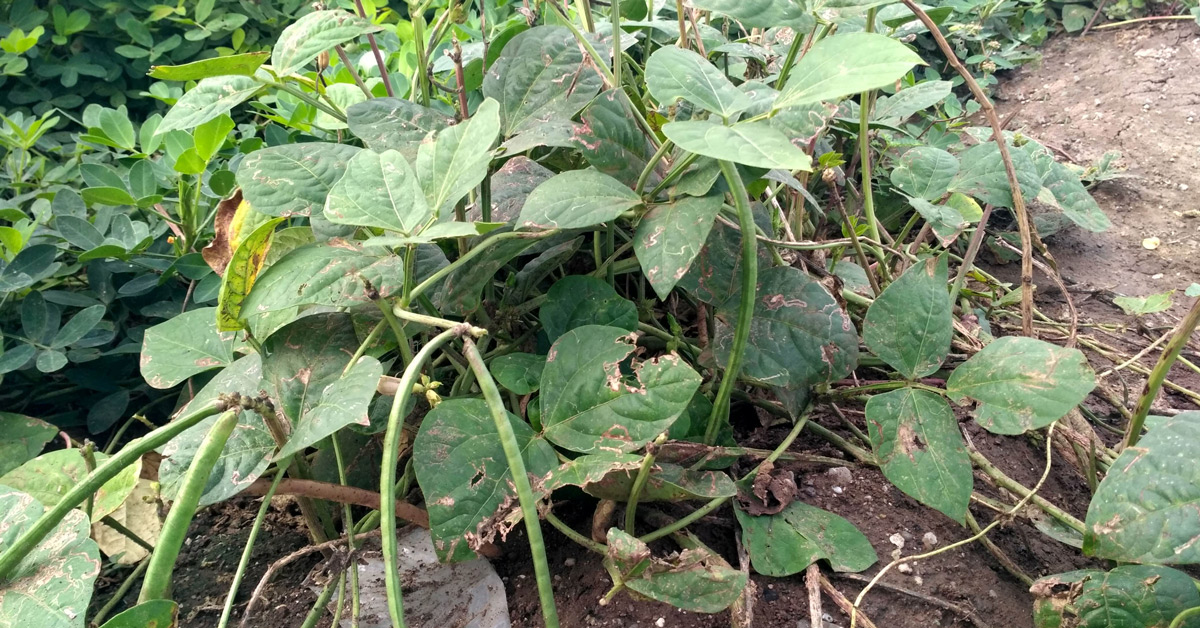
995, 22, 1200, 315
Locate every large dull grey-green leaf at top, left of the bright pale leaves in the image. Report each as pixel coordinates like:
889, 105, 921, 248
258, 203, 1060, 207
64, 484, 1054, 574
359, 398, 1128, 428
484, 26, 601, 137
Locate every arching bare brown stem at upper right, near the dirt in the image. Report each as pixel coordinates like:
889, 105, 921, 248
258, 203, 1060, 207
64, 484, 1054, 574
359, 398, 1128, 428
900, 0, 1033, 336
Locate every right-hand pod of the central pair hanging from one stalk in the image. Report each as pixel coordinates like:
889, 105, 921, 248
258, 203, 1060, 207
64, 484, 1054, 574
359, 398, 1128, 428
463, 339, 558, 628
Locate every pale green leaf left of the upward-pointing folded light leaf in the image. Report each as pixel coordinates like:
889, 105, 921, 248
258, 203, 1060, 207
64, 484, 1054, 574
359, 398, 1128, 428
324, 150, 432, 233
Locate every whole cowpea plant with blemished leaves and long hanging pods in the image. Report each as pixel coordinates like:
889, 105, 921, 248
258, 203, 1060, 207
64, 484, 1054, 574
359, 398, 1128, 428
0, 0, 1200, 627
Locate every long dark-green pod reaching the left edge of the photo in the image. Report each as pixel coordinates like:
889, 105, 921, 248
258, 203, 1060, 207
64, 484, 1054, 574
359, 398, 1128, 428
0, 401, 226, 582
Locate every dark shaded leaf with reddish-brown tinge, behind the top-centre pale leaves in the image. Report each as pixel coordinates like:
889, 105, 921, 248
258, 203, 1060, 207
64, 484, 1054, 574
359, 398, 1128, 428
573, 90, 658, 187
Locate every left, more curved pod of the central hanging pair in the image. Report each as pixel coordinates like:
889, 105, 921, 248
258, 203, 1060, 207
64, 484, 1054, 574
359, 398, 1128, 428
379, 329, 458, 628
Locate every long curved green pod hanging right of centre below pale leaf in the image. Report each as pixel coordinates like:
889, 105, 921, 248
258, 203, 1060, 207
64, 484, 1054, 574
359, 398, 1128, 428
704, 160, 758, 444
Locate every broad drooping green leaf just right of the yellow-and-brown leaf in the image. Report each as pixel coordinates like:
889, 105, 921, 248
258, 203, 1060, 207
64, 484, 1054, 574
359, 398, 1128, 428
241, 240, 405, 337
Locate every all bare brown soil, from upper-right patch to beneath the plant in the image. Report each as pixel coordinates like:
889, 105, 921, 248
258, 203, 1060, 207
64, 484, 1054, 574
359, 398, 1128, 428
88, 23, 1200, 628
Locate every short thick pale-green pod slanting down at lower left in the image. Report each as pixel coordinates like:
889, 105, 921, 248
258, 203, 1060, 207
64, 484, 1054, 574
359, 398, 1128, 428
138, 409, 240, 604
